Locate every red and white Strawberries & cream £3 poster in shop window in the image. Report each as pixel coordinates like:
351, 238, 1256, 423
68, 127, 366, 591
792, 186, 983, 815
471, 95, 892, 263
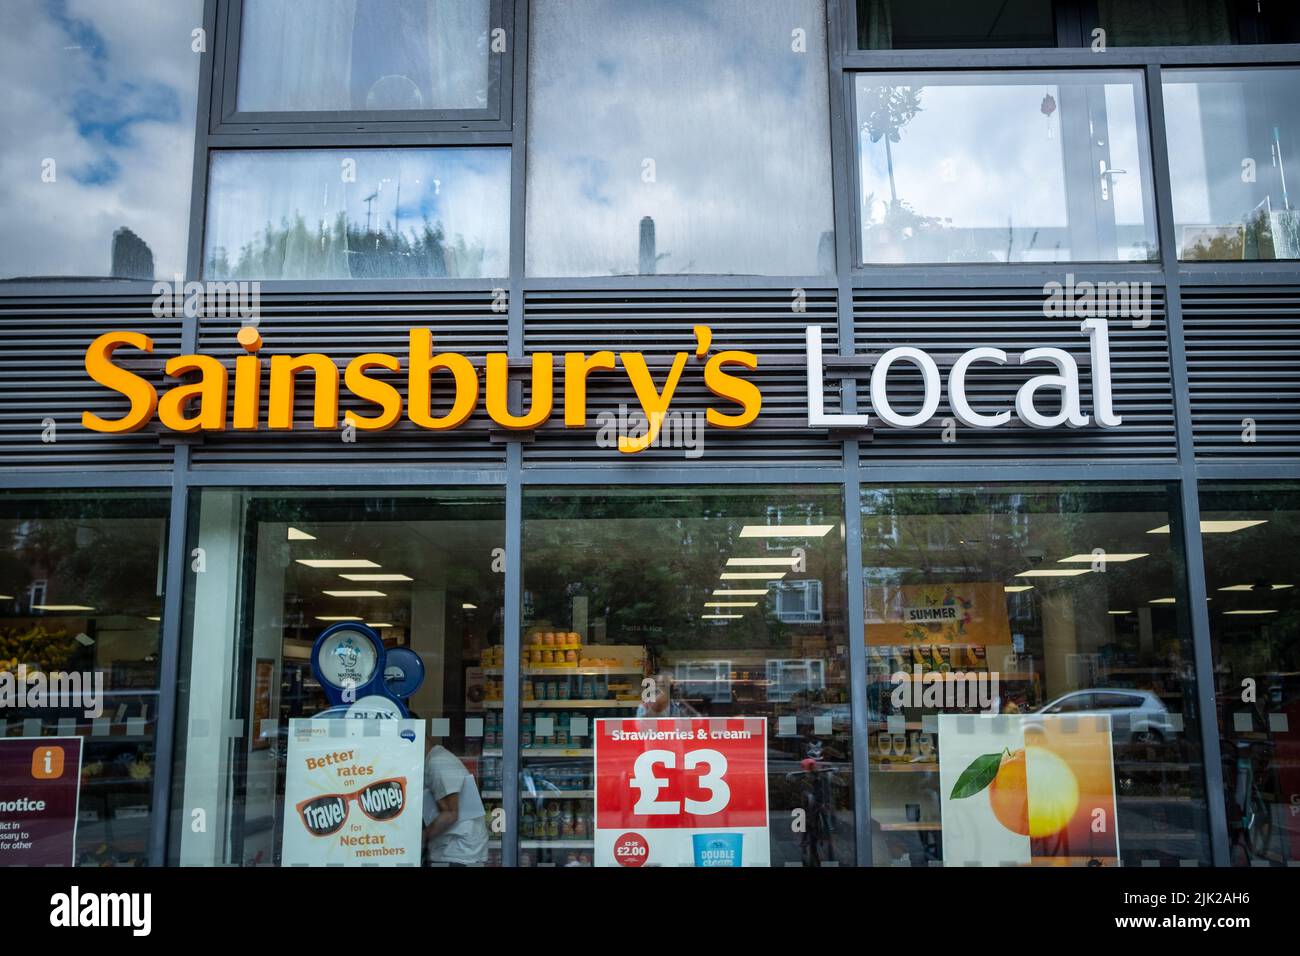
595, 717, 770, 868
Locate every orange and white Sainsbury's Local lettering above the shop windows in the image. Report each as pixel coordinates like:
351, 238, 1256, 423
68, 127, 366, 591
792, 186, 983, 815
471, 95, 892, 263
82, 319, 1122, 454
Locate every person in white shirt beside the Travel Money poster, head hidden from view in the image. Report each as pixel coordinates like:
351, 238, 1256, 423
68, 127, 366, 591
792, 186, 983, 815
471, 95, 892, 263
424, 740, 488, 866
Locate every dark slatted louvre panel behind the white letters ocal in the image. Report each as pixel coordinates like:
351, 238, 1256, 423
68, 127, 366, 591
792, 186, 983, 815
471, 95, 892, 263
853, 287, 1178, 464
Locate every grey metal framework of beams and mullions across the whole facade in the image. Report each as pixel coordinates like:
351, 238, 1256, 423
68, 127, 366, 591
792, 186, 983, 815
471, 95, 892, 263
0, 0, 1300, 866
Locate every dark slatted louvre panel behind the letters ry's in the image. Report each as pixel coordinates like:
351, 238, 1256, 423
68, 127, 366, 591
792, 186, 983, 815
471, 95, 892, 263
524, 289, 842, 467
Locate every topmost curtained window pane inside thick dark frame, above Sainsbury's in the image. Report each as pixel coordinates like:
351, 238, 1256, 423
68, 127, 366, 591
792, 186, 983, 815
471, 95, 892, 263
237, 0, 490, 112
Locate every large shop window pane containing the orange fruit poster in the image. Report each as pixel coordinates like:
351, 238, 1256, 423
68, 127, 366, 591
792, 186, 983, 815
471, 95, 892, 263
862, 485, 1209, 866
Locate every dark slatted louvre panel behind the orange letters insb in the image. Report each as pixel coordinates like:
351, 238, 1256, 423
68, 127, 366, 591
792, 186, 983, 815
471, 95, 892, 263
191, 290, 508, 470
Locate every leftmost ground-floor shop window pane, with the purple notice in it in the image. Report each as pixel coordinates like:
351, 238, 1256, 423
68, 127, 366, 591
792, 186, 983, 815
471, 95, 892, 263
0, 492, 168, 866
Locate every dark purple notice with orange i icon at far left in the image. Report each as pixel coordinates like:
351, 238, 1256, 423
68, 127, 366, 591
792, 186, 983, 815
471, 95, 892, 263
0, 737, 82, 866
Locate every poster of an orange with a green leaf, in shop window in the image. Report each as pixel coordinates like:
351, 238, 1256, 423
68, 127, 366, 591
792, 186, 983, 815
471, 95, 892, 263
939, 714, 1119, 866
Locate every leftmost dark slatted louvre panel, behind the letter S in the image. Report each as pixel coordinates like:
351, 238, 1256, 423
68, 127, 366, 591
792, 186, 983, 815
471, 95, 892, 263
0, 295, 181, 471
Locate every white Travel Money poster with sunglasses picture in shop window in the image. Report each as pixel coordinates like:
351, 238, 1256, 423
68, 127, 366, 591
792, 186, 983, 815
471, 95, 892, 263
281, 718, 424, 866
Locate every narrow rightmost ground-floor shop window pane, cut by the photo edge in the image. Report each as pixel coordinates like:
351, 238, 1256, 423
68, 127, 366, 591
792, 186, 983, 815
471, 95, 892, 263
1200, 483, 1300, 866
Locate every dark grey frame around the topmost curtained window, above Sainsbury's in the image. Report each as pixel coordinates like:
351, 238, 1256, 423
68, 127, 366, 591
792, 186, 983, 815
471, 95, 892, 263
209, 0, 515, 135
